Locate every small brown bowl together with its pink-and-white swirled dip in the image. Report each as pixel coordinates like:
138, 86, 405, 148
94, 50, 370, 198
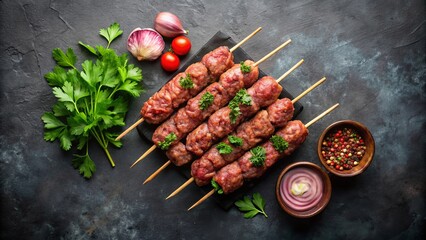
275, 162, 331, 218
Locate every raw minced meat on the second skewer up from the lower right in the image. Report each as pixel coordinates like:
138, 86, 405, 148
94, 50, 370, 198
191, 98, 294, 186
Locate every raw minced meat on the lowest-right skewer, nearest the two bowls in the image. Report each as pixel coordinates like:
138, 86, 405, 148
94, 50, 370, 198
213, 120, 309, 194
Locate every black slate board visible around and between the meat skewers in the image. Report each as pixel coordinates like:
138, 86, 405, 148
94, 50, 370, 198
137, 31, 303, 210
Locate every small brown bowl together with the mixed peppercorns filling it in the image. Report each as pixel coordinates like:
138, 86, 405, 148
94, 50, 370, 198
317, 120, 375, 177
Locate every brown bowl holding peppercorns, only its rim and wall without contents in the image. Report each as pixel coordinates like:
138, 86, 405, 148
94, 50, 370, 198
317, 120, 375, 177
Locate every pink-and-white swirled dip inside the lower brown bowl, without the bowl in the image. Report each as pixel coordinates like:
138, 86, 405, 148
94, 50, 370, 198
280, 167, 324, 211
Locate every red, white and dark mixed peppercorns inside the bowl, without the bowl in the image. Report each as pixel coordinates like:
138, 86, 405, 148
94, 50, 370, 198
321, 128, 366, 170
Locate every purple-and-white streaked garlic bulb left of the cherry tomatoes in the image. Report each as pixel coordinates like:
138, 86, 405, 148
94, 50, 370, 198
127, 28, 165, 61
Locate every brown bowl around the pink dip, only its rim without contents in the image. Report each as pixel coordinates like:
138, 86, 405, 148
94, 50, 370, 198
275, 162, 331, 218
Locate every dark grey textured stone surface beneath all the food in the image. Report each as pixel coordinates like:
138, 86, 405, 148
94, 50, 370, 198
0, 0, 426, 239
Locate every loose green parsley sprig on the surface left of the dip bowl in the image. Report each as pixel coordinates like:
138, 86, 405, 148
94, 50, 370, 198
235, 193, 268, 219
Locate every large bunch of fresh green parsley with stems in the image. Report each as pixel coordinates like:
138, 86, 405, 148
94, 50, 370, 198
41, 23, 143, 178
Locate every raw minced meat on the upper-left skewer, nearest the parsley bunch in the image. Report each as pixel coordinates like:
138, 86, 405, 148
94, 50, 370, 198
140, 47, 234, 124
